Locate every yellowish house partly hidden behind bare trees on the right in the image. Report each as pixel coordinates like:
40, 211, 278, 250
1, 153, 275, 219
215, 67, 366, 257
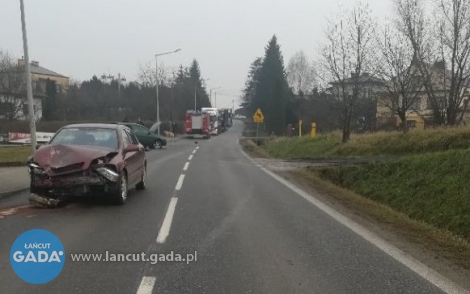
376, 61, 470, 129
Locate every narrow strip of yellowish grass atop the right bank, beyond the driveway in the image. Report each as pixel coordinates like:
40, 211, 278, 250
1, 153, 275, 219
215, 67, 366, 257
263, 127, 470, 159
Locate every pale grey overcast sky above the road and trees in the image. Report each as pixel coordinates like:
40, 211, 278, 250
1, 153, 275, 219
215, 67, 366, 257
0, 0, 392, 107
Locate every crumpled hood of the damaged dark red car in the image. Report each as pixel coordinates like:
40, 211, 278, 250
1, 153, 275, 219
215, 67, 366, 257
32, 145, 117, 169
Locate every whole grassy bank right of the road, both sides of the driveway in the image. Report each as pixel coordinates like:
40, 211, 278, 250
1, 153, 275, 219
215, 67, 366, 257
241, 137, 470, 269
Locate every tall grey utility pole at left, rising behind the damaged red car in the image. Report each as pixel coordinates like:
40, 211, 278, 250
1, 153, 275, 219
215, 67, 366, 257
20, 0, 36, 154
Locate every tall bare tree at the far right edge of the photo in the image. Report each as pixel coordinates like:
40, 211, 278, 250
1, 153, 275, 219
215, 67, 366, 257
438, 0, 470, 125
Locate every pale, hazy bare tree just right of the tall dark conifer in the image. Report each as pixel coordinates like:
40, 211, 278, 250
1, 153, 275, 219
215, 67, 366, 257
287, 51, 316, 94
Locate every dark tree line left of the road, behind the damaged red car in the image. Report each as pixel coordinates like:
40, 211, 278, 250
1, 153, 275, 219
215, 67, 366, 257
0, 52, 211, 126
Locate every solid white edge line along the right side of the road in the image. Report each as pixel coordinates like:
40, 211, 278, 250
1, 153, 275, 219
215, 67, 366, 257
240, 148, 470, 294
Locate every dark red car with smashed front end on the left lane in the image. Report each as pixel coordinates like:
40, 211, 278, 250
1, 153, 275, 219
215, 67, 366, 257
28, 124, 147, 206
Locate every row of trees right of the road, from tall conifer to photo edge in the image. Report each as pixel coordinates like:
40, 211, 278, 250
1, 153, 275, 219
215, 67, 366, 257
242, 0, 470, 142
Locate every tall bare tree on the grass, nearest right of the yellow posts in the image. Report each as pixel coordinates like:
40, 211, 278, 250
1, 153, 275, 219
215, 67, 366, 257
322, 3, 377, 142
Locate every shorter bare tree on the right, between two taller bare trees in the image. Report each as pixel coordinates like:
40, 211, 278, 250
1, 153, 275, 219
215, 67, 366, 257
379, 26, 423, 133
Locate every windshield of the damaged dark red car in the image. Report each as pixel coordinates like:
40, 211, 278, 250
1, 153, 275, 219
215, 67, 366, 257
51, 128, 118, 149
